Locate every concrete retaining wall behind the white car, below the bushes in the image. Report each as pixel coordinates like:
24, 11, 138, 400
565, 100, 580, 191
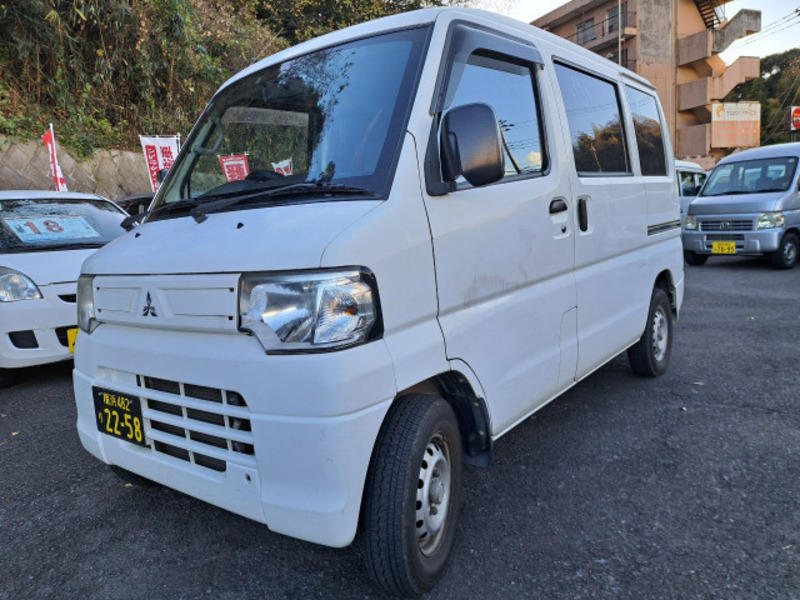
0, 136, 150, 200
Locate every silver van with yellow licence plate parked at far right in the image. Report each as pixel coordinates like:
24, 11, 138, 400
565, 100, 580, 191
683, 143, 800, 269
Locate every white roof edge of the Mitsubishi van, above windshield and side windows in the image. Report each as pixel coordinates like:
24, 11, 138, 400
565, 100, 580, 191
217, 7, 656, 92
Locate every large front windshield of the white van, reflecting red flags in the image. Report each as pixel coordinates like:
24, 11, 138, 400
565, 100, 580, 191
151, 28, 428, 219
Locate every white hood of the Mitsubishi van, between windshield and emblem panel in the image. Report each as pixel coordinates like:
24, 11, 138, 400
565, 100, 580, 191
83, 200, 381, 275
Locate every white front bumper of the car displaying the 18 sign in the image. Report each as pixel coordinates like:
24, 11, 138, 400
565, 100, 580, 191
0, 282, 78, 369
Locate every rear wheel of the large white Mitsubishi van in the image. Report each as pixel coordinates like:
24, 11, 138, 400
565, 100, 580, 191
628, 287, 673, 377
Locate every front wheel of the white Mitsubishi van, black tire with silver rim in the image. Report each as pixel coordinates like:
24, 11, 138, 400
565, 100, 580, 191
361, 395, 461, 596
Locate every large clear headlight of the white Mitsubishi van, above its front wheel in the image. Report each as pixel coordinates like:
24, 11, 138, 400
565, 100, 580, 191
239, 269, 381, 353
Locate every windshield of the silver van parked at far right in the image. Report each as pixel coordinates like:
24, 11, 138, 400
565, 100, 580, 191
700, 156, 797, 196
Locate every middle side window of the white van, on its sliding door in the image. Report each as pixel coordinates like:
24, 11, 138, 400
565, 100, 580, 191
556, 64, 630, 175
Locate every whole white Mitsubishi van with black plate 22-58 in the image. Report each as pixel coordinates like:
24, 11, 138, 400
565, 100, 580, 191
74, 8, 684, 595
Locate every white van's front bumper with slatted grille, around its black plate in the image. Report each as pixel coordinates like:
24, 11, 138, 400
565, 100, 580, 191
74, 324, 396, 547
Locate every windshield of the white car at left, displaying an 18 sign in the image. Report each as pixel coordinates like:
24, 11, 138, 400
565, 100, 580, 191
0, 198, 125, 253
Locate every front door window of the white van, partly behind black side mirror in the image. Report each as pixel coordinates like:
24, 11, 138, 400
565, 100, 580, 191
447, 53, 546, 179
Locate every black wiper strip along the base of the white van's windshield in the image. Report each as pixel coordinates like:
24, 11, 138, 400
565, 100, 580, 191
122, 181, 375, 231
